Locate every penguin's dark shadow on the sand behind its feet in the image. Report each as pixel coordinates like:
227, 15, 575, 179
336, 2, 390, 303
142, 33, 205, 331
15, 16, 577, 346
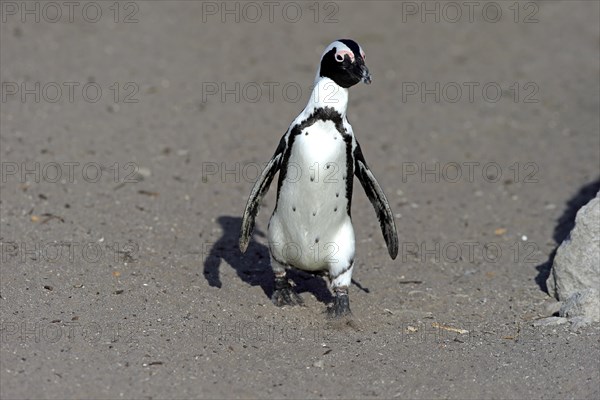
204, 215, 333, 304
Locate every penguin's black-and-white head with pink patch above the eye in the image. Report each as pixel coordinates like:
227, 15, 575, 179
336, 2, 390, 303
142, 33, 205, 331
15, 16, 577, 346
317, 39, 371, 88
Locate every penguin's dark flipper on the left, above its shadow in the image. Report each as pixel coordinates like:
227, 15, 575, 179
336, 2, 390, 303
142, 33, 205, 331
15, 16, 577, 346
240, 138, 285, 253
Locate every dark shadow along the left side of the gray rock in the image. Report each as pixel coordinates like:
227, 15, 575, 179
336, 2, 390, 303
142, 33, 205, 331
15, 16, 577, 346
535, 178, 600, 293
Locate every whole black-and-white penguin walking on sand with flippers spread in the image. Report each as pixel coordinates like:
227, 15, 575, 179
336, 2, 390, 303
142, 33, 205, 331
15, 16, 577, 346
239, 39, 398, 317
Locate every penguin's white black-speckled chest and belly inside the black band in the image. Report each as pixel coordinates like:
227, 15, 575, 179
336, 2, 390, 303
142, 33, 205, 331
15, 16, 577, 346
269, 121, 354, 270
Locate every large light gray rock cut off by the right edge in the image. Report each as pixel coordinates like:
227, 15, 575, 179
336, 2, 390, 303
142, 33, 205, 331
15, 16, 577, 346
547, 192, 600, 301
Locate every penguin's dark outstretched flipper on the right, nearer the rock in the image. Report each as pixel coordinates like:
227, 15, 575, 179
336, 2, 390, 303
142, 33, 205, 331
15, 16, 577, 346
354, 142, 398, 260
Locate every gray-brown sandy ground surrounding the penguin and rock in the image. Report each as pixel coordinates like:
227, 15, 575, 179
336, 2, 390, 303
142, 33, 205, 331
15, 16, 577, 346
0, 1, 600, 399
